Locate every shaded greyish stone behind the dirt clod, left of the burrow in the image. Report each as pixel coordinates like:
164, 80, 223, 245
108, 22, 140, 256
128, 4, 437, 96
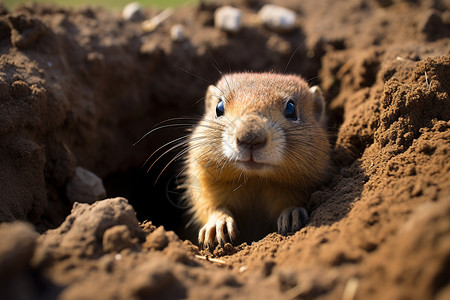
66, 167, 106, 204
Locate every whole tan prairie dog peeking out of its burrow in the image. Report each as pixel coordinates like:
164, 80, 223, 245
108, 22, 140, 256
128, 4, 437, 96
185, 73, 330, 248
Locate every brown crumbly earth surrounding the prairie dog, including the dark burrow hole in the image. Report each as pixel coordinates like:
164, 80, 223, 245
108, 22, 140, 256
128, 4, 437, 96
0, 0, 450, 300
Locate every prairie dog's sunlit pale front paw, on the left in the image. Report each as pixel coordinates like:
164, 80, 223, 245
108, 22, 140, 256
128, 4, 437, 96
198, 211, 238, 251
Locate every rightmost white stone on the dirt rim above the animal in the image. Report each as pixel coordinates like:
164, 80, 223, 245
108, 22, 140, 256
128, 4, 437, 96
258, 4, 297, 31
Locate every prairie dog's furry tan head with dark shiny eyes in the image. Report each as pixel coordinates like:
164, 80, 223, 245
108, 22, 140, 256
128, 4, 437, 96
195, 73, 329, 184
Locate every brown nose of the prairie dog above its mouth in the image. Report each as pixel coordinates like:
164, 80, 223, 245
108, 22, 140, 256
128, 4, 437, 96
236, 115, 267, 149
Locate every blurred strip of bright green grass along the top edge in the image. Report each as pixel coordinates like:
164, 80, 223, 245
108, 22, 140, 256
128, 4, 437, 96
3, 0, 199, 9
